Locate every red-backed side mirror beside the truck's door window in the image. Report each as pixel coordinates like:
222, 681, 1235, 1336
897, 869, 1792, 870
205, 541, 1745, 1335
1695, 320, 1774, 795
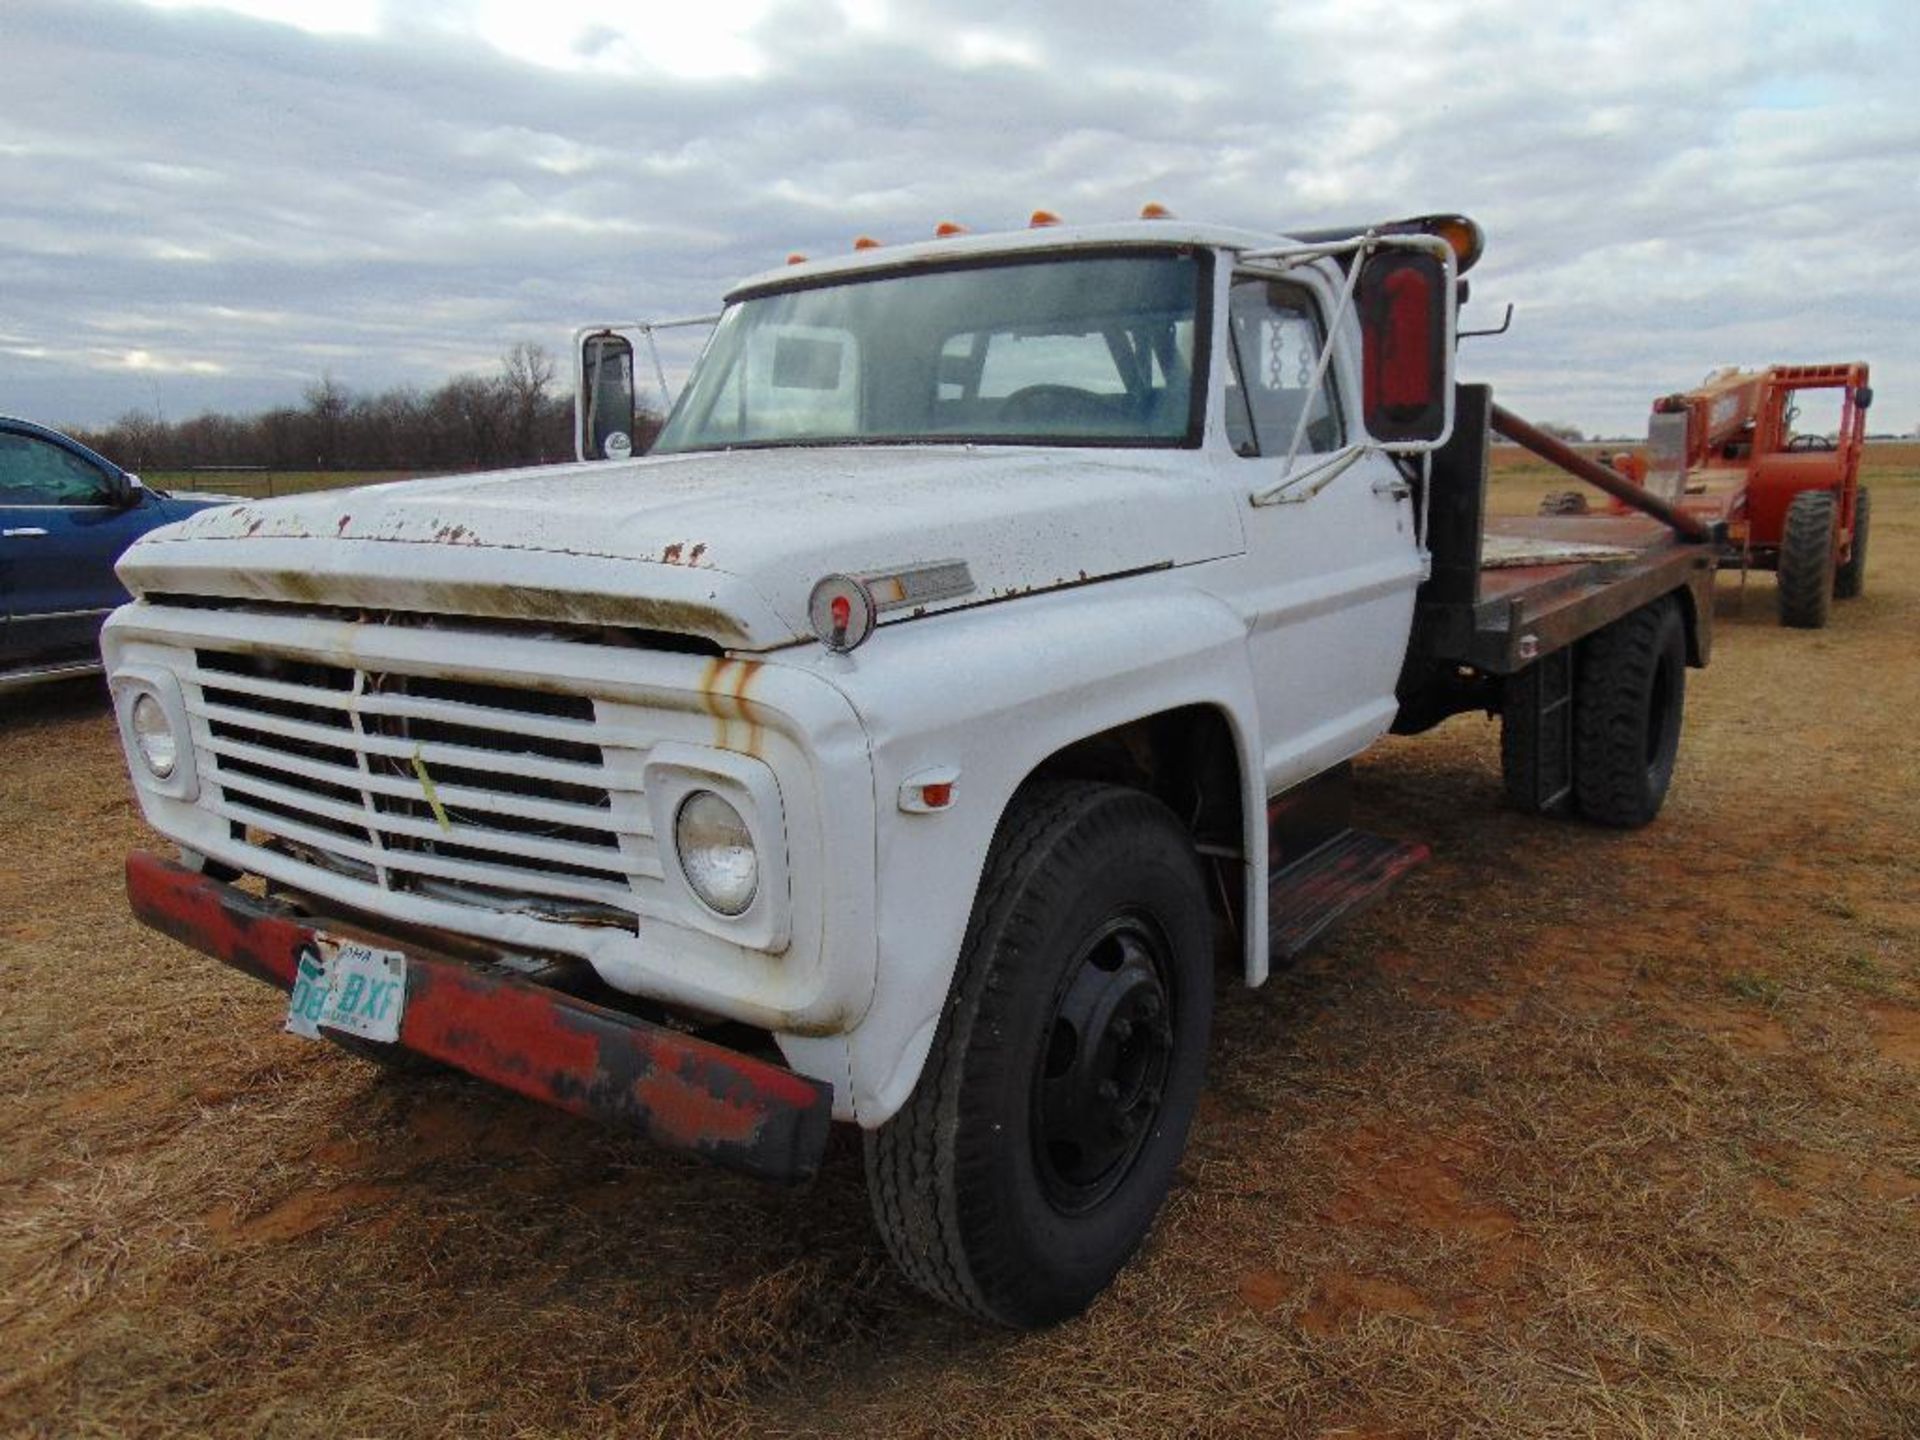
1356, 250, 1453, 445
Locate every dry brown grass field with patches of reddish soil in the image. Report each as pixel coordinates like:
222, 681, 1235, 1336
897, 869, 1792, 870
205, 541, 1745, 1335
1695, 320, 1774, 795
0, 447, 1920, 1438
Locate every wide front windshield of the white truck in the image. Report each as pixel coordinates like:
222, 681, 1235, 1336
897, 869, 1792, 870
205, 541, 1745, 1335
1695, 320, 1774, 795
653, 252, 1204, 455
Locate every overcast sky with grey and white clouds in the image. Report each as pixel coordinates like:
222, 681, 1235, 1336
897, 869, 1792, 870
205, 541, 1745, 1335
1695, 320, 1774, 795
0, 0, 1920, 434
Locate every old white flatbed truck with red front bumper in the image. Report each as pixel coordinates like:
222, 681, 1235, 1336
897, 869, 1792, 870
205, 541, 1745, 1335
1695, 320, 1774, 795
104, 217, 1713, 1325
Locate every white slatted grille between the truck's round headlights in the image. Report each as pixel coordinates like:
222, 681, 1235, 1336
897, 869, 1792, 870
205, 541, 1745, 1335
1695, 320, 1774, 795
182, 649, 660, 929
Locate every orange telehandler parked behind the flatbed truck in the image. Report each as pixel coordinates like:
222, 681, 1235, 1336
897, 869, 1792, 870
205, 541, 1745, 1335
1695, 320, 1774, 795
1611, 361, 1874, 630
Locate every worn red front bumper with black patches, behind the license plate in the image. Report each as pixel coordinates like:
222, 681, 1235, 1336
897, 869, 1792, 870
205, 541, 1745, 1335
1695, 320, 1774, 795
127, 851, 833, 1181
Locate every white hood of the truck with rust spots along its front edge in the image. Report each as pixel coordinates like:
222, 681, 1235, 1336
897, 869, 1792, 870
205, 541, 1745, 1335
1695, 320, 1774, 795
121, 445, 1242, 649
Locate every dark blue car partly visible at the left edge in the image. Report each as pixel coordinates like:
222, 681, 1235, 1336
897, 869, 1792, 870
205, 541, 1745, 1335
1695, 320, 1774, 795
0, 417, 230, 689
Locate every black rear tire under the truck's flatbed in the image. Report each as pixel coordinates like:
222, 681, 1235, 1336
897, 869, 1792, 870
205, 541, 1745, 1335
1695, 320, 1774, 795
1572, 595, 1686, 828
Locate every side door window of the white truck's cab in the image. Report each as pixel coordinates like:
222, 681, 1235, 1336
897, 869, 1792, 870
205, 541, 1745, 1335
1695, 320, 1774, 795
1227, 276, 1346, 455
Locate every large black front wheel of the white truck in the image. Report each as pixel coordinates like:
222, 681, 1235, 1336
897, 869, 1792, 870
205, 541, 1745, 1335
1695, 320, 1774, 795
866, 783, 1213, 1329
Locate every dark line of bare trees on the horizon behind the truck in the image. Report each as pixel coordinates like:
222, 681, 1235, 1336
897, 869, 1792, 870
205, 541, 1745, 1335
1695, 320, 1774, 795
73, 342, 659, 472
